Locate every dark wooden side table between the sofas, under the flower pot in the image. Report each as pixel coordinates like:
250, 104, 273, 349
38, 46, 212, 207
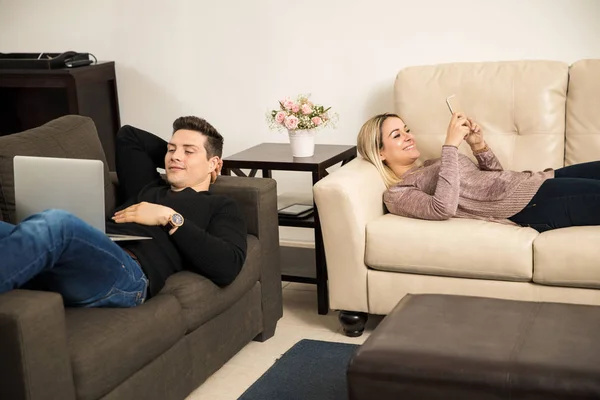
221, 143, 356, 314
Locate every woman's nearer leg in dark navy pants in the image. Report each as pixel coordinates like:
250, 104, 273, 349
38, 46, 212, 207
510, 178, 600, 232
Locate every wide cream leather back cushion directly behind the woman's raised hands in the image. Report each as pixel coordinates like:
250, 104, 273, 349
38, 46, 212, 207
394, 61, 568, 171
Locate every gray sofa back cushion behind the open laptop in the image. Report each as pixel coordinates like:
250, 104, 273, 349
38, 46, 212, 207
0, 115, 115, 223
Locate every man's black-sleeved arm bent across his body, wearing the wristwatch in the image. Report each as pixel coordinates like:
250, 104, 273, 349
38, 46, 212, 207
170, 199, 247, 286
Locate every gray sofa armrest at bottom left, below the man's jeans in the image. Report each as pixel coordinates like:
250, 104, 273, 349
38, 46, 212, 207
0, 290, 75, 400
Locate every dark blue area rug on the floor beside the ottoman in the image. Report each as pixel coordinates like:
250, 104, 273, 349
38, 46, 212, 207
238, 339, 358, 400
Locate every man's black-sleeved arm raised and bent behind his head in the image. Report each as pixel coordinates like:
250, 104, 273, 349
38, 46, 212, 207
116, 125, 167, 201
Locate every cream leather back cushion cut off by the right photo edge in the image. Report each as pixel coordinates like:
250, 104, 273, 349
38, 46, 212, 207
565, 60, 600, 165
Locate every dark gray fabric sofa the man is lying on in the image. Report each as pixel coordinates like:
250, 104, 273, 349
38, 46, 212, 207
0, 116, 282, 400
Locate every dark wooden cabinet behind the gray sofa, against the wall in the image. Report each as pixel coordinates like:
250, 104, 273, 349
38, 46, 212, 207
0, 61, 121, 171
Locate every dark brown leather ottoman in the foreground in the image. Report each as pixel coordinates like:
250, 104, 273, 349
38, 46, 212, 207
348, 295, 600, 400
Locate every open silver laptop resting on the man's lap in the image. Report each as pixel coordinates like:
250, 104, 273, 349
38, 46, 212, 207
13, 156, 152, 242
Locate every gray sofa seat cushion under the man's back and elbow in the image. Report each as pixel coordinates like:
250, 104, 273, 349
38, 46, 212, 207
159, 235, 261, 332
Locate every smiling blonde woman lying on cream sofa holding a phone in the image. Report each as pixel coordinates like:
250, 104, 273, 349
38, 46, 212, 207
358, 113, 600, 232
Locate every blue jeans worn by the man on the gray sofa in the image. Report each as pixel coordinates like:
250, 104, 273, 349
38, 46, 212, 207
0, 210, 148, 307
